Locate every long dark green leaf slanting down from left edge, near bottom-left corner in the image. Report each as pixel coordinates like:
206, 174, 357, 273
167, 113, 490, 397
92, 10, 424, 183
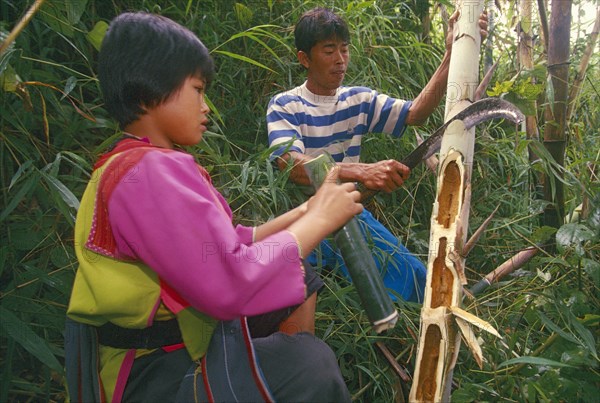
0, 306, 63, 374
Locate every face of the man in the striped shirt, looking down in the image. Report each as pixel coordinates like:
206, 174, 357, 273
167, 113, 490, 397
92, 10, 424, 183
298, 38, 350, 95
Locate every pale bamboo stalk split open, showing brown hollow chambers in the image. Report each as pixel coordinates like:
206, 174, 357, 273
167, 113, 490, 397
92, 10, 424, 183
410, 0, 496, 402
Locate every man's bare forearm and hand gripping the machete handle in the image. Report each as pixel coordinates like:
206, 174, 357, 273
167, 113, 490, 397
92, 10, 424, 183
277, 151, 410, 192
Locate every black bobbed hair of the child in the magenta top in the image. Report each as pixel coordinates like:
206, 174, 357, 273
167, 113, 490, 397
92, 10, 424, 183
98, 13, 214, 128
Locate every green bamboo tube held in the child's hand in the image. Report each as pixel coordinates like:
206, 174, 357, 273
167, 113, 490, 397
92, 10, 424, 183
304, 153, 398, 333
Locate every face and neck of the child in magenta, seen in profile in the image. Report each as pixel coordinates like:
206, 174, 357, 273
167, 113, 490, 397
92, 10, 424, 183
144, 76, 210, 148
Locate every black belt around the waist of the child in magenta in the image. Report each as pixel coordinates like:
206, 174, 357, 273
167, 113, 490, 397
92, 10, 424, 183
98, 319, 183, 349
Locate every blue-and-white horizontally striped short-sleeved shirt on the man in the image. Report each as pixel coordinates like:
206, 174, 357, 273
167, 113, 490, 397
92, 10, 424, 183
267, 82, 411, 162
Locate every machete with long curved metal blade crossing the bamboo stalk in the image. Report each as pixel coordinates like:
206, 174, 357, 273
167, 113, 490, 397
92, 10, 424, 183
362, 98, 525, 202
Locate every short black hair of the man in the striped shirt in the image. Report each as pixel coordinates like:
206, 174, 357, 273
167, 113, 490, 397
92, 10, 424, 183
294, 7, 350, 55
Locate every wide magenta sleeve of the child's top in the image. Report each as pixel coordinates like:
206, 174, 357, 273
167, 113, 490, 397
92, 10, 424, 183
108, 152, 305, 320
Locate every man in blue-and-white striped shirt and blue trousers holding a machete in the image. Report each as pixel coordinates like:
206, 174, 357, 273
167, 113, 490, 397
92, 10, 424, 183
267, 8, 487, 302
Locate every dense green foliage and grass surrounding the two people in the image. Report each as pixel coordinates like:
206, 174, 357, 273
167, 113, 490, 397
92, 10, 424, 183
0, 0, 600, 402
